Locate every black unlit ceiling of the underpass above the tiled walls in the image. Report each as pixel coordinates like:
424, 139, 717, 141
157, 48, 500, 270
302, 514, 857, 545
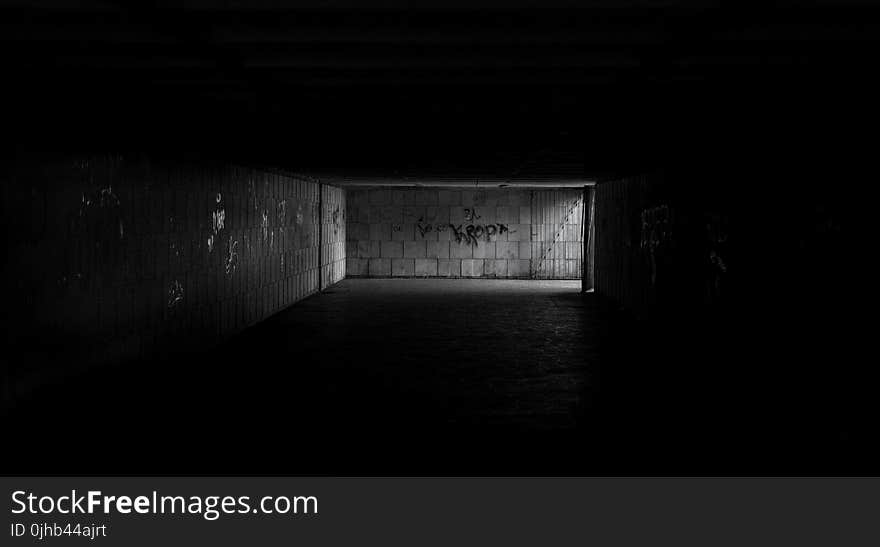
0, 0, 880, 184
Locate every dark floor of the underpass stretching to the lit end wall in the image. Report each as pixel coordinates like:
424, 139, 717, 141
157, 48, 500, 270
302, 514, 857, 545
8, 279, 874, 475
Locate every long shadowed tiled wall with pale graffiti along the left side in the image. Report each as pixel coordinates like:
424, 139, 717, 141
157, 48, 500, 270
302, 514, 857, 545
0, 157, 345, 404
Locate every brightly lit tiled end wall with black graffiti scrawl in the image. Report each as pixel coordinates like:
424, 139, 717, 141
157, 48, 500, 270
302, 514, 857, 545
346, 187, 584, 279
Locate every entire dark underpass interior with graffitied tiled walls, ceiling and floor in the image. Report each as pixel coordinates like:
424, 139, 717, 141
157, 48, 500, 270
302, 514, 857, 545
0, 0, 880, 476
